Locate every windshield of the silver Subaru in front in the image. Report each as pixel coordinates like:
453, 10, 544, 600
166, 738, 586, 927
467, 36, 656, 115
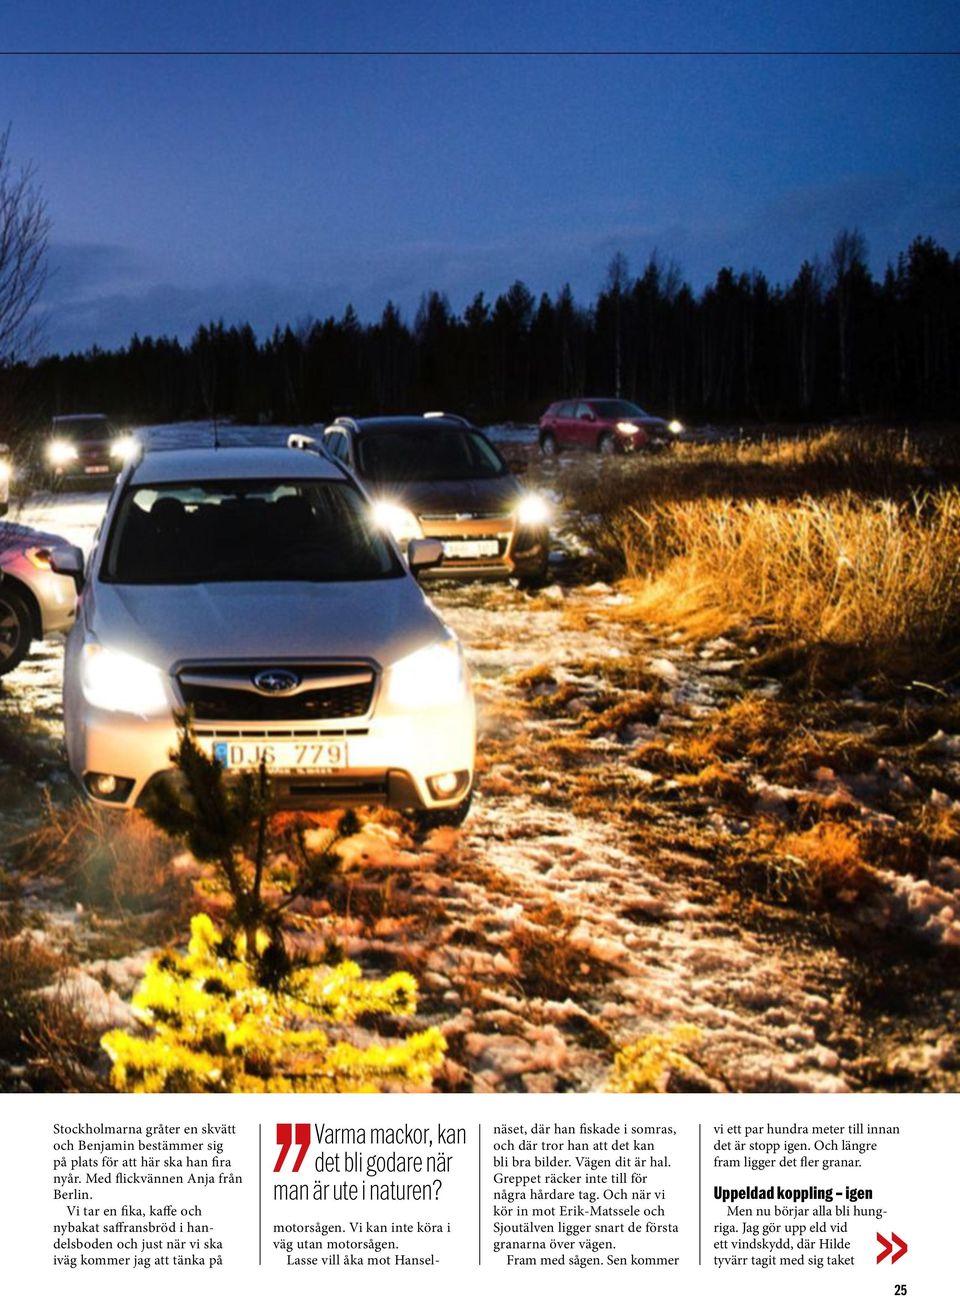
100, 480, 405, 585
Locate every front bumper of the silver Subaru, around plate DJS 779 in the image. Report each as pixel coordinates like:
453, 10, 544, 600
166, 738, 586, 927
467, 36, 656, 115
67, 691, 476, 811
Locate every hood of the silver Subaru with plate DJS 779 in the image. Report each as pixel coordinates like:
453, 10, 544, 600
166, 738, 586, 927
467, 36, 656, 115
90, 576, 445, 669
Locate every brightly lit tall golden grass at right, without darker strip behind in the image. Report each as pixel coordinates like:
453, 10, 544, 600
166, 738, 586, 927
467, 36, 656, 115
617, 489, 960, 664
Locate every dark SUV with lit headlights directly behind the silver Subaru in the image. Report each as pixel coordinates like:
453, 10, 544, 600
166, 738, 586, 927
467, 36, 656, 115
299, 414, 550, 584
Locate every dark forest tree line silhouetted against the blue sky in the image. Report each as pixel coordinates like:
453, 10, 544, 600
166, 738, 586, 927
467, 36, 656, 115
16, 230, 960, 423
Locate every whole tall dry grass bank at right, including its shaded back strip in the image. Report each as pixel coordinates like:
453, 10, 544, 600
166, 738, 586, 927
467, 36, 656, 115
573, 429, 960, 684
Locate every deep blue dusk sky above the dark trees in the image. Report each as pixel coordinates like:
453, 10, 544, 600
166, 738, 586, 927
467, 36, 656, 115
0, 0, 960, 350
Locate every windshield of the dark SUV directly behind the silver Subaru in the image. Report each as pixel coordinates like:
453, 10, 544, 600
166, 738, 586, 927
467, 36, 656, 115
357, 425, 510, 482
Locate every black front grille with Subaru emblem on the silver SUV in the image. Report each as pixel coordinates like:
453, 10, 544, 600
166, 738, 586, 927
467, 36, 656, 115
176, 663, 376, 724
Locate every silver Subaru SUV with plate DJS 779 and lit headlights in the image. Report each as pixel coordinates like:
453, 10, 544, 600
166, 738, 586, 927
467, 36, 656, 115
54, 447, 475, 822
